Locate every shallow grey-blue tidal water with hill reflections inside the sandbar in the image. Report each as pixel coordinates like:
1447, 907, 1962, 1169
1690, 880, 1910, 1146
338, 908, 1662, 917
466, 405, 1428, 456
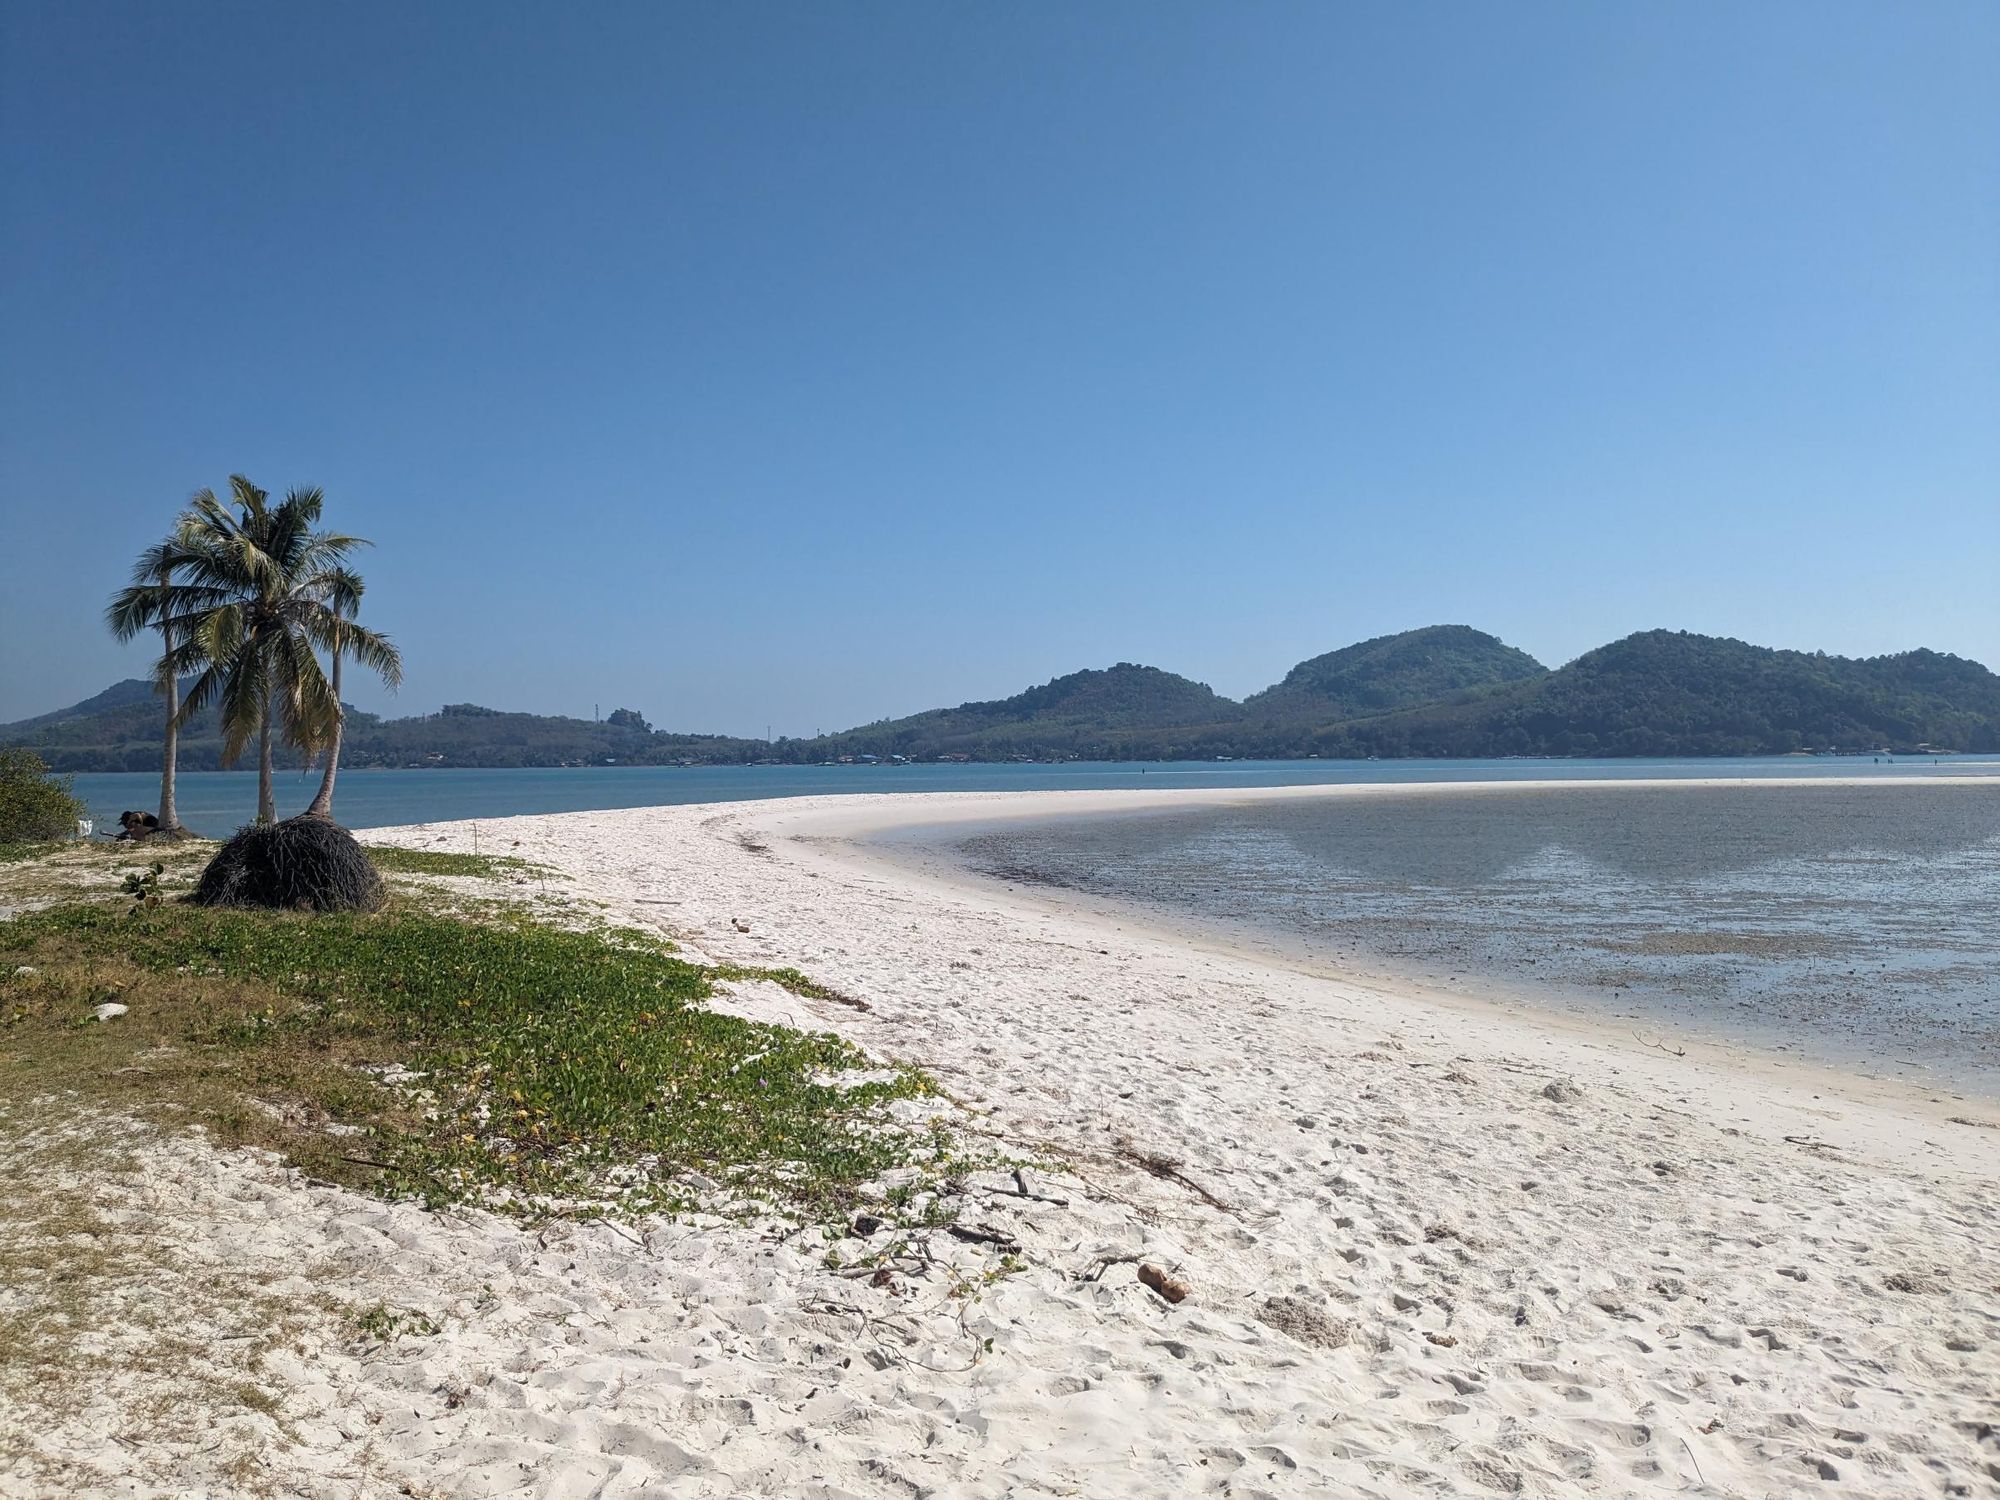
956, 784, 2000, 1090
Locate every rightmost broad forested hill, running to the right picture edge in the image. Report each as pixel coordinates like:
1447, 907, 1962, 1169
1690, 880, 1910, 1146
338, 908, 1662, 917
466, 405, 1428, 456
1310, 630, 2000, 756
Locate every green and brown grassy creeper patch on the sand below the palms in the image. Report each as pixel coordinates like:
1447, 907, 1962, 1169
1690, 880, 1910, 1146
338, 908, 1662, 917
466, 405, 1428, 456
0, 904, 950, 1216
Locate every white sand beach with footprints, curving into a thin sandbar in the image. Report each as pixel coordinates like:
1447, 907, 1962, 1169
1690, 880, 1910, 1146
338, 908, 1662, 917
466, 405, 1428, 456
0, 788, 2000, 1500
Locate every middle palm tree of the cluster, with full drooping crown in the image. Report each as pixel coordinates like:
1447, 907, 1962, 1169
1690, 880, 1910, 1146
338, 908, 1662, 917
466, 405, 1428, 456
178, 474, 402, 824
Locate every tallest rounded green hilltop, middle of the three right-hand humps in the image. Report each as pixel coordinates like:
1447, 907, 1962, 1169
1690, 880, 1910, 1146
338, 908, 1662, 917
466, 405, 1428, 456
1244, 626, 1548, 724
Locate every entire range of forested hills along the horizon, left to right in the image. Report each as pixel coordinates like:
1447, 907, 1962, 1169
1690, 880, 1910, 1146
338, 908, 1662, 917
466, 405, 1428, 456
15, 626, 2000, 770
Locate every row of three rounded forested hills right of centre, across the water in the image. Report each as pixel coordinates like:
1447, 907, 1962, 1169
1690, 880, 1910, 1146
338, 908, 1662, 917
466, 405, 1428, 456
778, 626, 2000, 760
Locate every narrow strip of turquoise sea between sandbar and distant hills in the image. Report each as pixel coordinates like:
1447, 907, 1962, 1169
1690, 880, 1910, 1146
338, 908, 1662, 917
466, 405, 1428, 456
76, 756, 2000, 834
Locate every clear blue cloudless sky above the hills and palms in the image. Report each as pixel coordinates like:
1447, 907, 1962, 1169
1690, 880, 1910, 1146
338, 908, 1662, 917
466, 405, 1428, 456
0, 0, 2000, 734
